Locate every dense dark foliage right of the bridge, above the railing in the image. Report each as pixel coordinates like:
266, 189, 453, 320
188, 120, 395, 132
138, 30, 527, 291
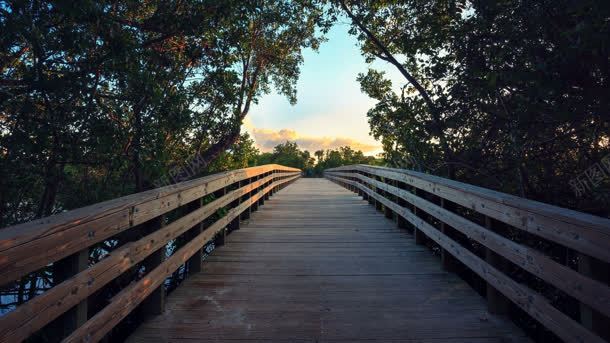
337, 0, 610, 215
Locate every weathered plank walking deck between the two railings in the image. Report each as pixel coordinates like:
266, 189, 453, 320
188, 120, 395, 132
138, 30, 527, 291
128, 179, 526, 343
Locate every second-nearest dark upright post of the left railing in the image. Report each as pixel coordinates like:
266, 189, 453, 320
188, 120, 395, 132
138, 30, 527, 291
141, 215, 167, 316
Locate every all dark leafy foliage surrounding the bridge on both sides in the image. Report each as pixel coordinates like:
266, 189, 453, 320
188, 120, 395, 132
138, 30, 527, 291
0, 0, 610, 342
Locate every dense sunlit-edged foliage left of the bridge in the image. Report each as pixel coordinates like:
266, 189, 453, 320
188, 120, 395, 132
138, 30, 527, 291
0, 0, 328, 227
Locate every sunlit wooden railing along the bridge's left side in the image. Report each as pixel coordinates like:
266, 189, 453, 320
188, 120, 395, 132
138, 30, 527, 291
0, 165, 301, 342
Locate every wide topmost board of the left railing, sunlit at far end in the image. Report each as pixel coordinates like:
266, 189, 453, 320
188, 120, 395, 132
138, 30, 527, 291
0, 165, 300, 285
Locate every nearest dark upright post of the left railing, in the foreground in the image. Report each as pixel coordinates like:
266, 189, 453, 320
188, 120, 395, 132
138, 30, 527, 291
52, 249, 89, 337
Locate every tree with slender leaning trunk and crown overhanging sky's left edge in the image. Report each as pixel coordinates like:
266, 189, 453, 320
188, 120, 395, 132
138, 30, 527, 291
191, 1, 330, 175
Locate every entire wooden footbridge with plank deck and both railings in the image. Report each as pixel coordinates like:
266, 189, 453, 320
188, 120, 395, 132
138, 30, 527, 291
0, 165, 610, 342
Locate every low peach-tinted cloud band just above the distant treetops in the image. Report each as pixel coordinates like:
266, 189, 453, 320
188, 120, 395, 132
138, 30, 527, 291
246, 125, 381, 153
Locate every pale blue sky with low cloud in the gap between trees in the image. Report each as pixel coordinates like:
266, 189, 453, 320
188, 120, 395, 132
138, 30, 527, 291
244, 22, 401, 155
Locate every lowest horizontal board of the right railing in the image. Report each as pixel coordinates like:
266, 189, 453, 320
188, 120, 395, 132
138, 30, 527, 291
329, 176, 604, 343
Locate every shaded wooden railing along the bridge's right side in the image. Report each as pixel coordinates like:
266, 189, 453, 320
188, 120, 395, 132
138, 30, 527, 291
325, 165, 610, 342
